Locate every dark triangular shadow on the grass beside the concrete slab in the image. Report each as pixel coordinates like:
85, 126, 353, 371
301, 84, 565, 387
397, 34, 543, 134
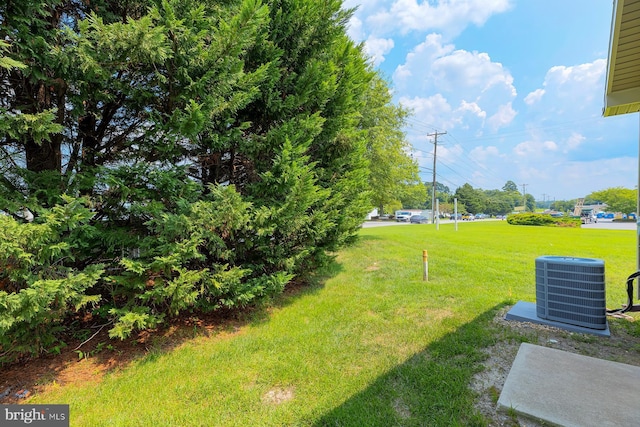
314, 304, 506, 427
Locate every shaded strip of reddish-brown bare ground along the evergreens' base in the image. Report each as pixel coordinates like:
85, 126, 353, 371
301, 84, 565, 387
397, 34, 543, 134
0, 259, 342, 404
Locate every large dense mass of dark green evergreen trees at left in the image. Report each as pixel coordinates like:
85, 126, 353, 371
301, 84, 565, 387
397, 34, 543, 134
0, 0, 401, 363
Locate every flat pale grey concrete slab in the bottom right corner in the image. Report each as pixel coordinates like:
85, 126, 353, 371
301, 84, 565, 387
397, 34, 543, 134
498, 343, 640, 427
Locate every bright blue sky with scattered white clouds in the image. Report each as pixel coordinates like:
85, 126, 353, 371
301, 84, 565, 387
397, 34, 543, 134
344, 0, 640, 201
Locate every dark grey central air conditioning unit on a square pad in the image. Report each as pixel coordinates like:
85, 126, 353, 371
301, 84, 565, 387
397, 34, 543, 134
536, 256, 607, 329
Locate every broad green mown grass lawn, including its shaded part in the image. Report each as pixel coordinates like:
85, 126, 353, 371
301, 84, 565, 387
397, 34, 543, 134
29, 221, 636, 427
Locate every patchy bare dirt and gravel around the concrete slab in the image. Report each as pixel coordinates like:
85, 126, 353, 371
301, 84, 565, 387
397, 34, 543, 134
471, 307, 640, 427
